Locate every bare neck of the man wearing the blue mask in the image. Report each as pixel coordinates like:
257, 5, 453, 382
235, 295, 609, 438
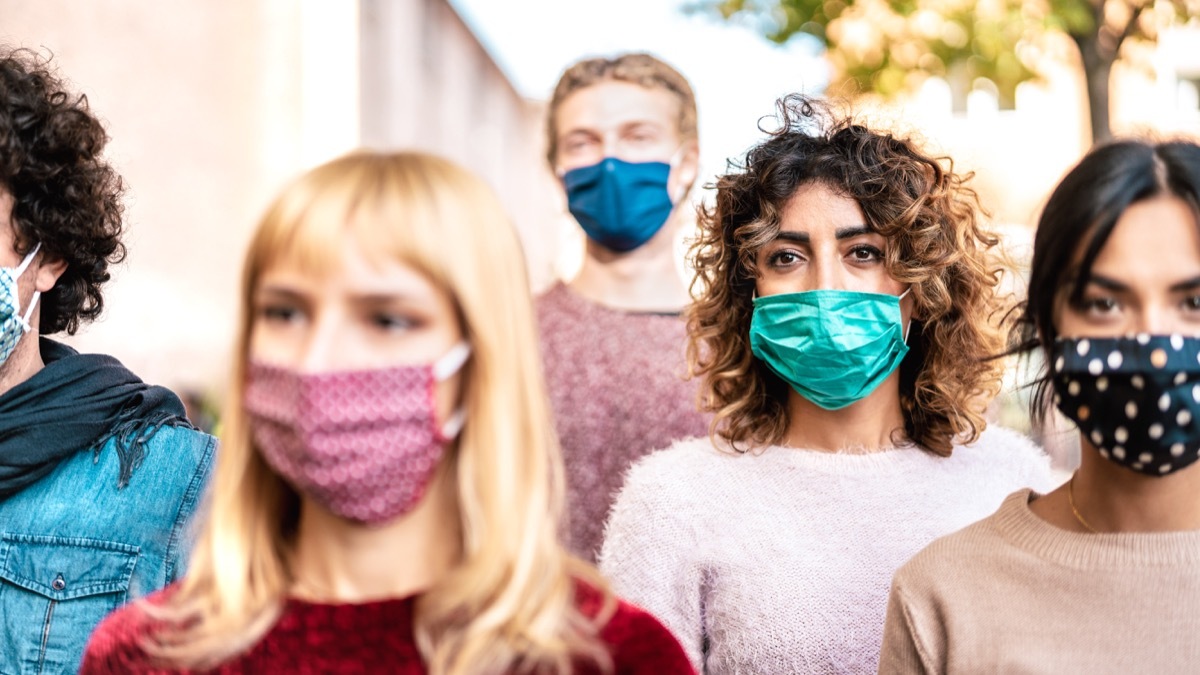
570, 214, 689, 312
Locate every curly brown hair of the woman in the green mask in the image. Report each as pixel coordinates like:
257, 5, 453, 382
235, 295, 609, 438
686, 95, 1004, 456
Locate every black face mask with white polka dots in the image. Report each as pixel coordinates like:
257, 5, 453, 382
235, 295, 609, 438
1050, 334, 1200, 476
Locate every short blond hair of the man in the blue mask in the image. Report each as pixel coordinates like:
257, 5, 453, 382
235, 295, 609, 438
546, 53, 696, 168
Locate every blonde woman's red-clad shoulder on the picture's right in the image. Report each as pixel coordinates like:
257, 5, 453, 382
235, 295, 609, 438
576, 583, 695, 675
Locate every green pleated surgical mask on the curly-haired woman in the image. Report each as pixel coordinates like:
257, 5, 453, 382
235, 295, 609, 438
750, 285, 908, 410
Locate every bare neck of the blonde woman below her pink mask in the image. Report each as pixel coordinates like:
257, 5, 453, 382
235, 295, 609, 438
292, 461, 462, 603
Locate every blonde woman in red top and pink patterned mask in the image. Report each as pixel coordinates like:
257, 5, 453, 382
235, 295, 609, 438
83, 154, 691, 674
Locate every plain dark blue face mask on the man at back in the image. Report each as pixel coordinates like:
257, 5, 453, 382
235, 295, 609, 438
563, 157, 674, 253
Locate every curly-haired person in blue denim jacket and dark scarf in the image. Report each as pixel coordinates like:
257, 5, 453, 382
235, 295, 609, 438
0, 50, 216, 674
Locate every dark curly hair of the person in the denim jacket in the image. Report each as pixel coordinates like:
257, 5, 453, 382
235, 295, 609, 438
0, 49, 125, 334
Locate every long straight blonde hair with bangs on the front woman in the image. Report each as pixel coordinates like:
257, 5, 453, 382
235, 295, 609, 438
145, 153, 614, 674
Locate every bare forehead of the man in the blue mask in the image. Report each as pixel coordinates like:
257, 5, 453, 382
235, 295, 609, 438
554, 79, 680, 137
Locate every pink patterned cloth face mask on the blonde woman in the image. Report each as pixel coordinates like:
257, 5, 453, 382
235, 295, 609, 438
244, 344, 470, 525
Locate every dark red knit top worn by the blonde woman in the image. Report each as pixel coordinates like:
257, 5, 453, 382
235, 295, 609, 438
80, 586, 695, 675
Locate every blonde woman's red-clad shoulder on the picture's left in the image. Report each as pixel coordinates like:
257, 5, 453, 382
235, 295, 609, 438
79, 585, 175, 675
